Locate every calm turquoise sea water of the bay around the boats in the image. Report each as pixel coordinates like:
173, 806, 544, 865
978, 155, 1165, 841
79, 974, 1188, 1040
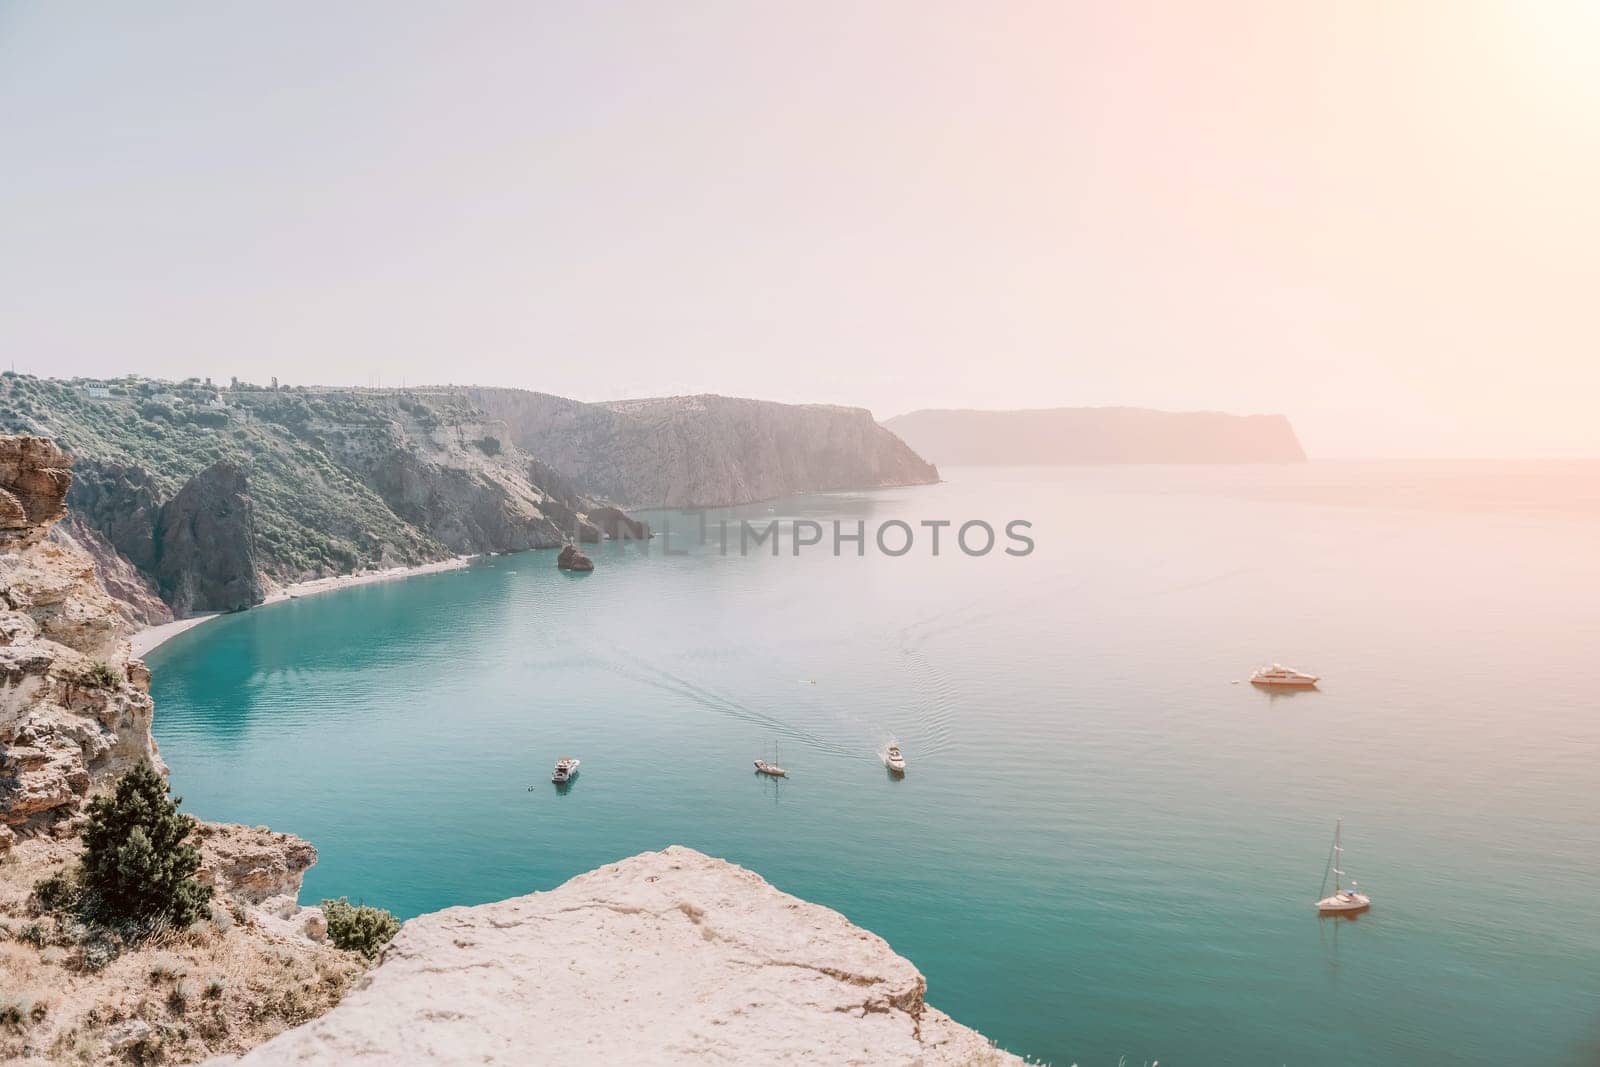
152, 464, 1600, 1067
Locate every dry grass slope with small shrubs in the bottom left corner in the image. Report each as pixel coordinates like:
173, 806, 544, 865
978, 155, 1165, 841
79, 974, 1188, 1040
0, 840, 365, 1064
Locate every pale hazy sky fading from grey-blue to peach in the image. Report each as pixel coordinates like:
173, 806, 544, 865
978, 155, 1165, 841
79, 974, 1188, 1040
0, 0, 1600, 458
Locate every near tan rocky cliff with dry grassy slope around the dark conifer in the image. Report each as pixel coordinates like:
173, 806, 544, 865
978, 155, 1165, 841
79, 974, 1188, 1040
0, 437, 365, 1064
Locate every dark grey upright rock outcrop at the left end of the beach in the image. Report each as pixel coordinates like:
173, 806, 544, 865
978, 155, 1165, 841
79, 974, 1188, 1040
155, 459, 266, 617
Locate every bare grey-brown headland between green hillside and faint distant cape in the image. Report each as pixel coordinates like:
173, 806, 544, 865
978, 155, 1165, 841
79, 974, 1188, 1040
467, 389, 939, 507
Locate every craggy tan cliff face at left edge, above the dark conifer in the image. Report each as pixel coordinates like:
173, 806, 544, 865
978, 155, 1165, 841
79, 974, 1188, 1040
0, 435, 165, 843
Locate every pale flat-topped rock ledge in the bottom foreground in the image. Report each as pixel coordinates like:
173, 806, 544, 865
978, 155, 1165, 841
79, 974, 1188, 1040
216, 846, 1022, 1067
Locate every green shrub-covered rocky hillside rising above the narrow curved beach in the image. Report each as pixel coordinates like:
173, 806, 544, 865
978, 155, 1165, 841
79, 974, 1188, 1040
0, 373, 646, 617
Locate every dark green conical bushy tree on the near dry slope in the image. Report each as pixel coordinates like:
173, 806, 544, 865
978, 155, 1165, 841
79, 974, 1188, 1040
82, 763, 211, 926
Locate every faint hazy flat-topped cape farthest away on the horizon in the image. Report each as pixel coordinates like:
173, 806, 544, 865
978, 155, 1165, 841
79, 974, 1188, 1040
883, 408, 1306, 466
